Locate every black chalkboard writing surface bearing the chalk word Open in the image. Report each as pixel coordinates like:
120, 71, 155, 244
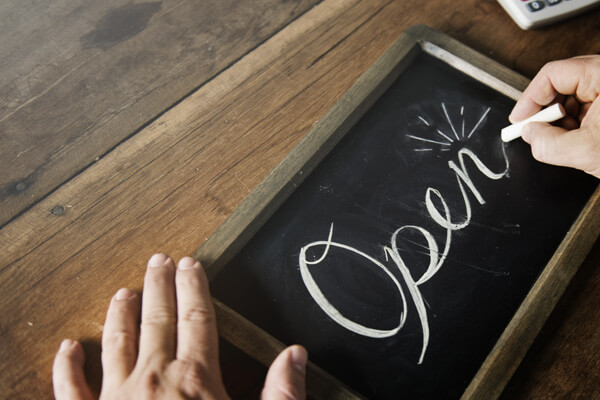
200, 28, 598, 399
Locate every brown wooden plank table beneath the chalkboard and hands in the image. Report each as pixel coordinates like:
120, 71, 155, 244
0, 0, 600, 399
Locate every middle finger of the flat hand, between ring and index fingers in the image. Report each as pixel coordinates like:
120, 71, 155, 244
138, 254, 177, 365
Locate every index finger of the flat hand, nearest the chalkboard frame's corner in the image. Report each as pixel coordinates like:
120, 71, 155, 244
175, 257, 219, 372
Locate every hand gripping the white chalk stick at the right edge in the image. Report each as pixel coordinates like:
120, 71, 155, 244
509, 56, 600, 178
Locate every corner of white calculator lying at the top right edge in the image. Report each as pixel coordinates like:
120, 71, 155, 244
498, 0, 600, 29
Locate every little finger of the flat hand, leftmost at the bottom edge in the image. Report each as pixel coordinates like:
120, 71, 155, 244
52, 339, 93, 400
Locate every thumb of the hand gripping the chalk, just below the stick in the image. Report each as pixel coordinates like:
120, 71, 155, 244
523, 122, 600, 174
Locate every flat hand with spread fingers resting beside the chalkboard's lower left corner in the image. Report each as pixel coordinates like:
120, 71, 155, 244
53, 254, 307, 400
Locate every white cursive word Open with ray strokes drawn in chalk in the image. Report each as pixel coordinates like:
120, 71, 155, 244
298, 103, 509, 364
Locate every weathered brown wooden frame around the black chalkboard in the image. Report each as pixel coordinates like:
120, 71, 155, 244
194, 25, 600, 399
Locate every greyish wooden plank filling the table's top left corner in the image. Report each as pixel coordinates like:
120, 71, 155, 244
0, 0, 317, 226
